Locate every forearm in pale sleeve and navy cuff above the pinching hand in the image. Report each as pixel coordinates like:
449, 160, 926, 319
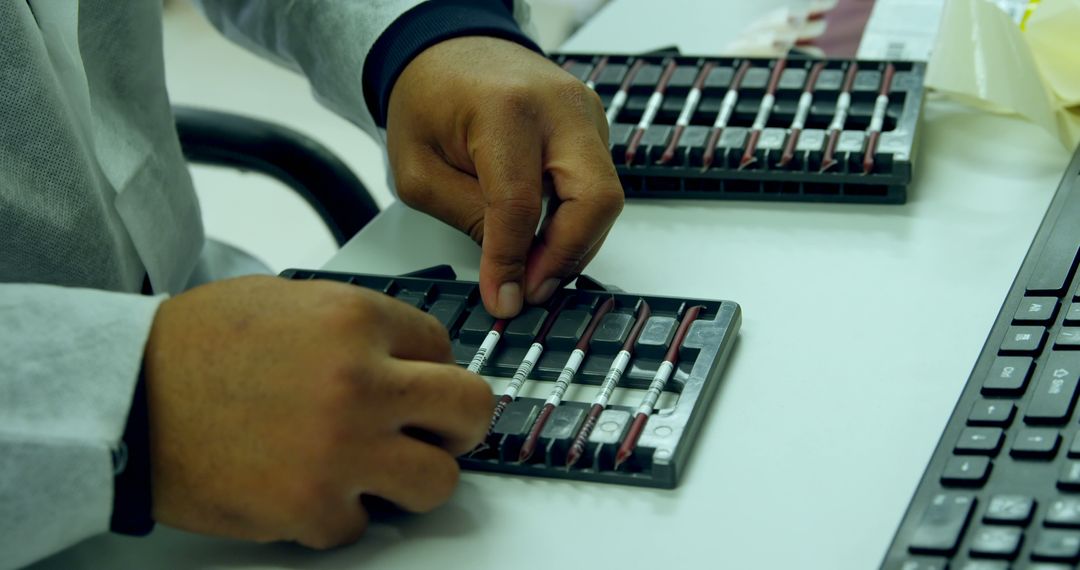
194, 0, 535, 138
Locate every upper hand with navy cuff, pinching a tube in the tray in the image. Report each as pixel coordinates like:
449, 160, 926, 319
387, 37, 623, 316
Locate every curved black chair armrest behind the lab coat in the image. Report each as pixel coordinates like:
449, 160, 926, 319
173, 106, 379, 246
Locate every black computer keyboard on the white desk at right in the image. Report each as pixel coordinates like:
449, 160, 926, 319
882, 149, 1080, 570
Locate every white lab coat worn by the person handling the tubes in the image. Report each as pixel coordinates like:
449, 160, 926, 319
0, 0, 524, 568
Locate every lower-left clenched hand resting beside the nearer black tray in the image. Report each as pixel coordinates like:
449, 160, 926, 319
144, 277, 491, 547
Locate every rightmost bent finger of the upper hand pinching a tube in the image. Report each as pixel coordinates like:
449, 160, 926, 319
525, 125, 623, 303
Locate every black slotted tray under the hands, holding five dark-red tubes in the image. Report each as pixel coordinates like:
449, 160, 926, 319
282, 269, 741, 488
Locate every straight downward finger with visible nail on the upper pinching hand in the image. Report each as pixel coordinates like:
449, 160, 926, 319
471, 111, 543, 317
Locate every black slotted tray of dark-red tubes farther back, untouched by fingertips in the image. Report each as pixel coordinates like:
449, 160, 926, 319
551, 53, 926, 204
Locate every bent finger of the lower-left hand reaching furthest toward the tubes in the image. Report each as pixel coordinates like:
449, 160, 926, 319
391, 361, 494, 456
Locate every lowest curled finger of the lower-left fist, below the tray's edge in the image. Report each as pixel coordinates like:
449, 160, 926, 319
364, 435, 460, 513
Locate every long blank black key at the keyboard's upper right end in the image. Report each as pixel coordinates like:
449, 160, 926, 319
1027, 180, 1080, 295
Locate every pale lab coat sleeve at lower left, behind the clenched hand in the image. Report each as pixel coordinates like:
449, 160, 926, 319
0, 283, 163, 568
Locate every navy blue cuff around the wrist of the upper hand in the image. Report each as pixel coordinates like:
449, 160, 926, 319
363, 0, 543, 128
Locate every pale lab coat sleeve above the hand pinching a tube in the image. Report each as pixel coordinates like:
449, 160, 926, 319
194, 0, 535, 140
